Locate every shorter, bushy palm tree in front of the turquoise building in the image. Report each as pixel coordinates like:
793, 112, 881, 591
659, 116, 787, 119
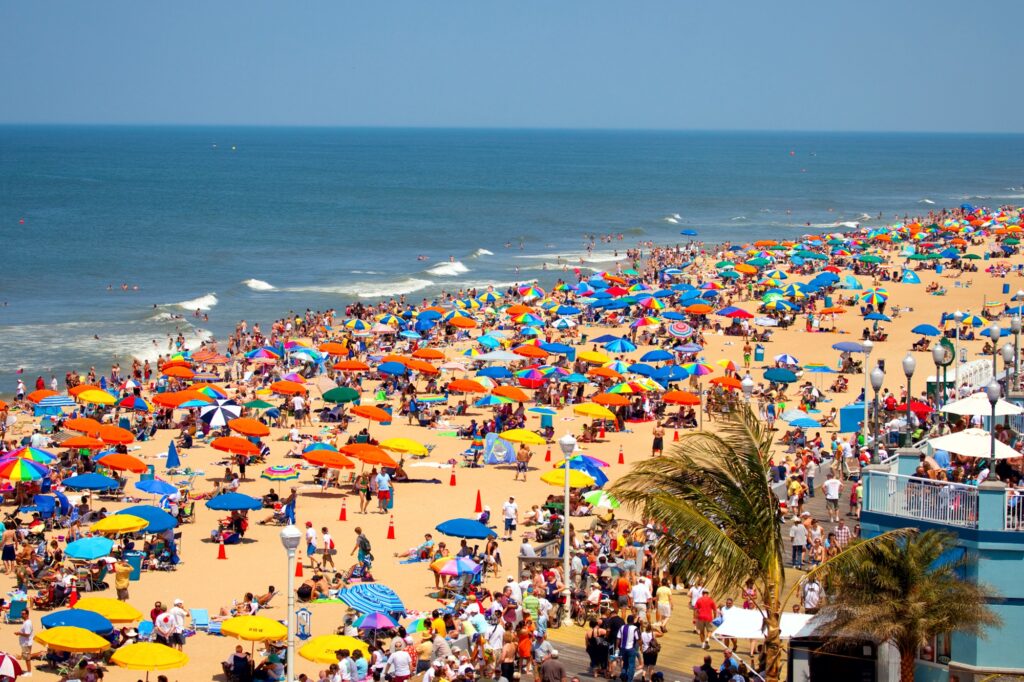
818, 530, 1000, 682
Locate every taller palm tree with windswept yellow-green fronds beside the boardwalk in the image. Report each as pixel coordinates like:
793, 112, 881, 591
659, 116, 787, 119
611, 407, 899, 682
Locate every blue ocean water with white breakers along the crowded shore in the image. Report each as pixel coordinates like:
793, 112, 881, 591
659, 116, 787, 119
0, 127, 1024, 385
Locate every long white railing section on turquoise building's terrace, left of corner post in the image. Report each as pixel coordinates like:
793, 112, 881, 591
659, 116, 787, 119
864, 471, 978, 528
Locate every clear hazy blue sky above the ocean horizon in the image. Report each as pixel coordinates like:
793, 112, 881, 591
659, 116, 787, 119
0, 0, 1024, 132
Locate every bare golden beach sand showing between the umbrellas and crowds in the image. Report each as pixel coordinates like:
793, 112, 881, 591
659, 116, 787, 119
0, 204, 1024, 682
